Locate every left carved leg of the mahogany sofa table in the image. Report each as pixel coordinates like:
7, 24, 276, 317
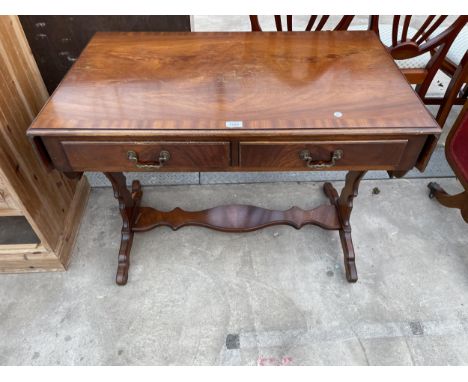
104, 172, 142, 285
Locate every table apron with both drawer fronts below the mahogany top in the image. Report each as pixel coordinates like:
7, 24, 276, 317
35, 136, 427, 172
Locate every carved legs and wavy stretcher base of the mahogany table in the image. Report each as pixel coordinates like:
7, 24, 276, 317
104, 171, 365, 285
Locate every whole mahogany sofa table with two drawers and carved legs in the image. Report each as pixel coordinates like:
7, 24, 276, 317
28, 31, 440, 285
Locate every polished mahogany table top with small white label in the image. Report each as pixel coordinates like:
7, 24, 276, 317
30, 31, 440, 135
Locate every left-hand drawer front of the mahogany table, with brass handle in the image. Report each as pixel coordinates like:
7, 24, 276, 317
62, 141, 230, 172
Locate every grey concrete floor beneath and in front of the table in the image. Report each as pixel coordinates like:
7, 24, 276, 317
0, 178, 468, 365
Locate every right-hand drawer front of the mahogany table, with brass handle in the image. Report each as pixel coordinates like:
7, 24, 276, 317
239, 140, 408, 170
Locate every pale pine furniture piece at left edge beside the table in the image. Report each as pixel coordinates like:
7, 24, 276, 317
0, 16, 89, 272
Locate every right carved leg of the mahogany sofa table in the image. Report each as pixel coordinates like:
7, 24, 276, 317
323, 171, 366, 282
